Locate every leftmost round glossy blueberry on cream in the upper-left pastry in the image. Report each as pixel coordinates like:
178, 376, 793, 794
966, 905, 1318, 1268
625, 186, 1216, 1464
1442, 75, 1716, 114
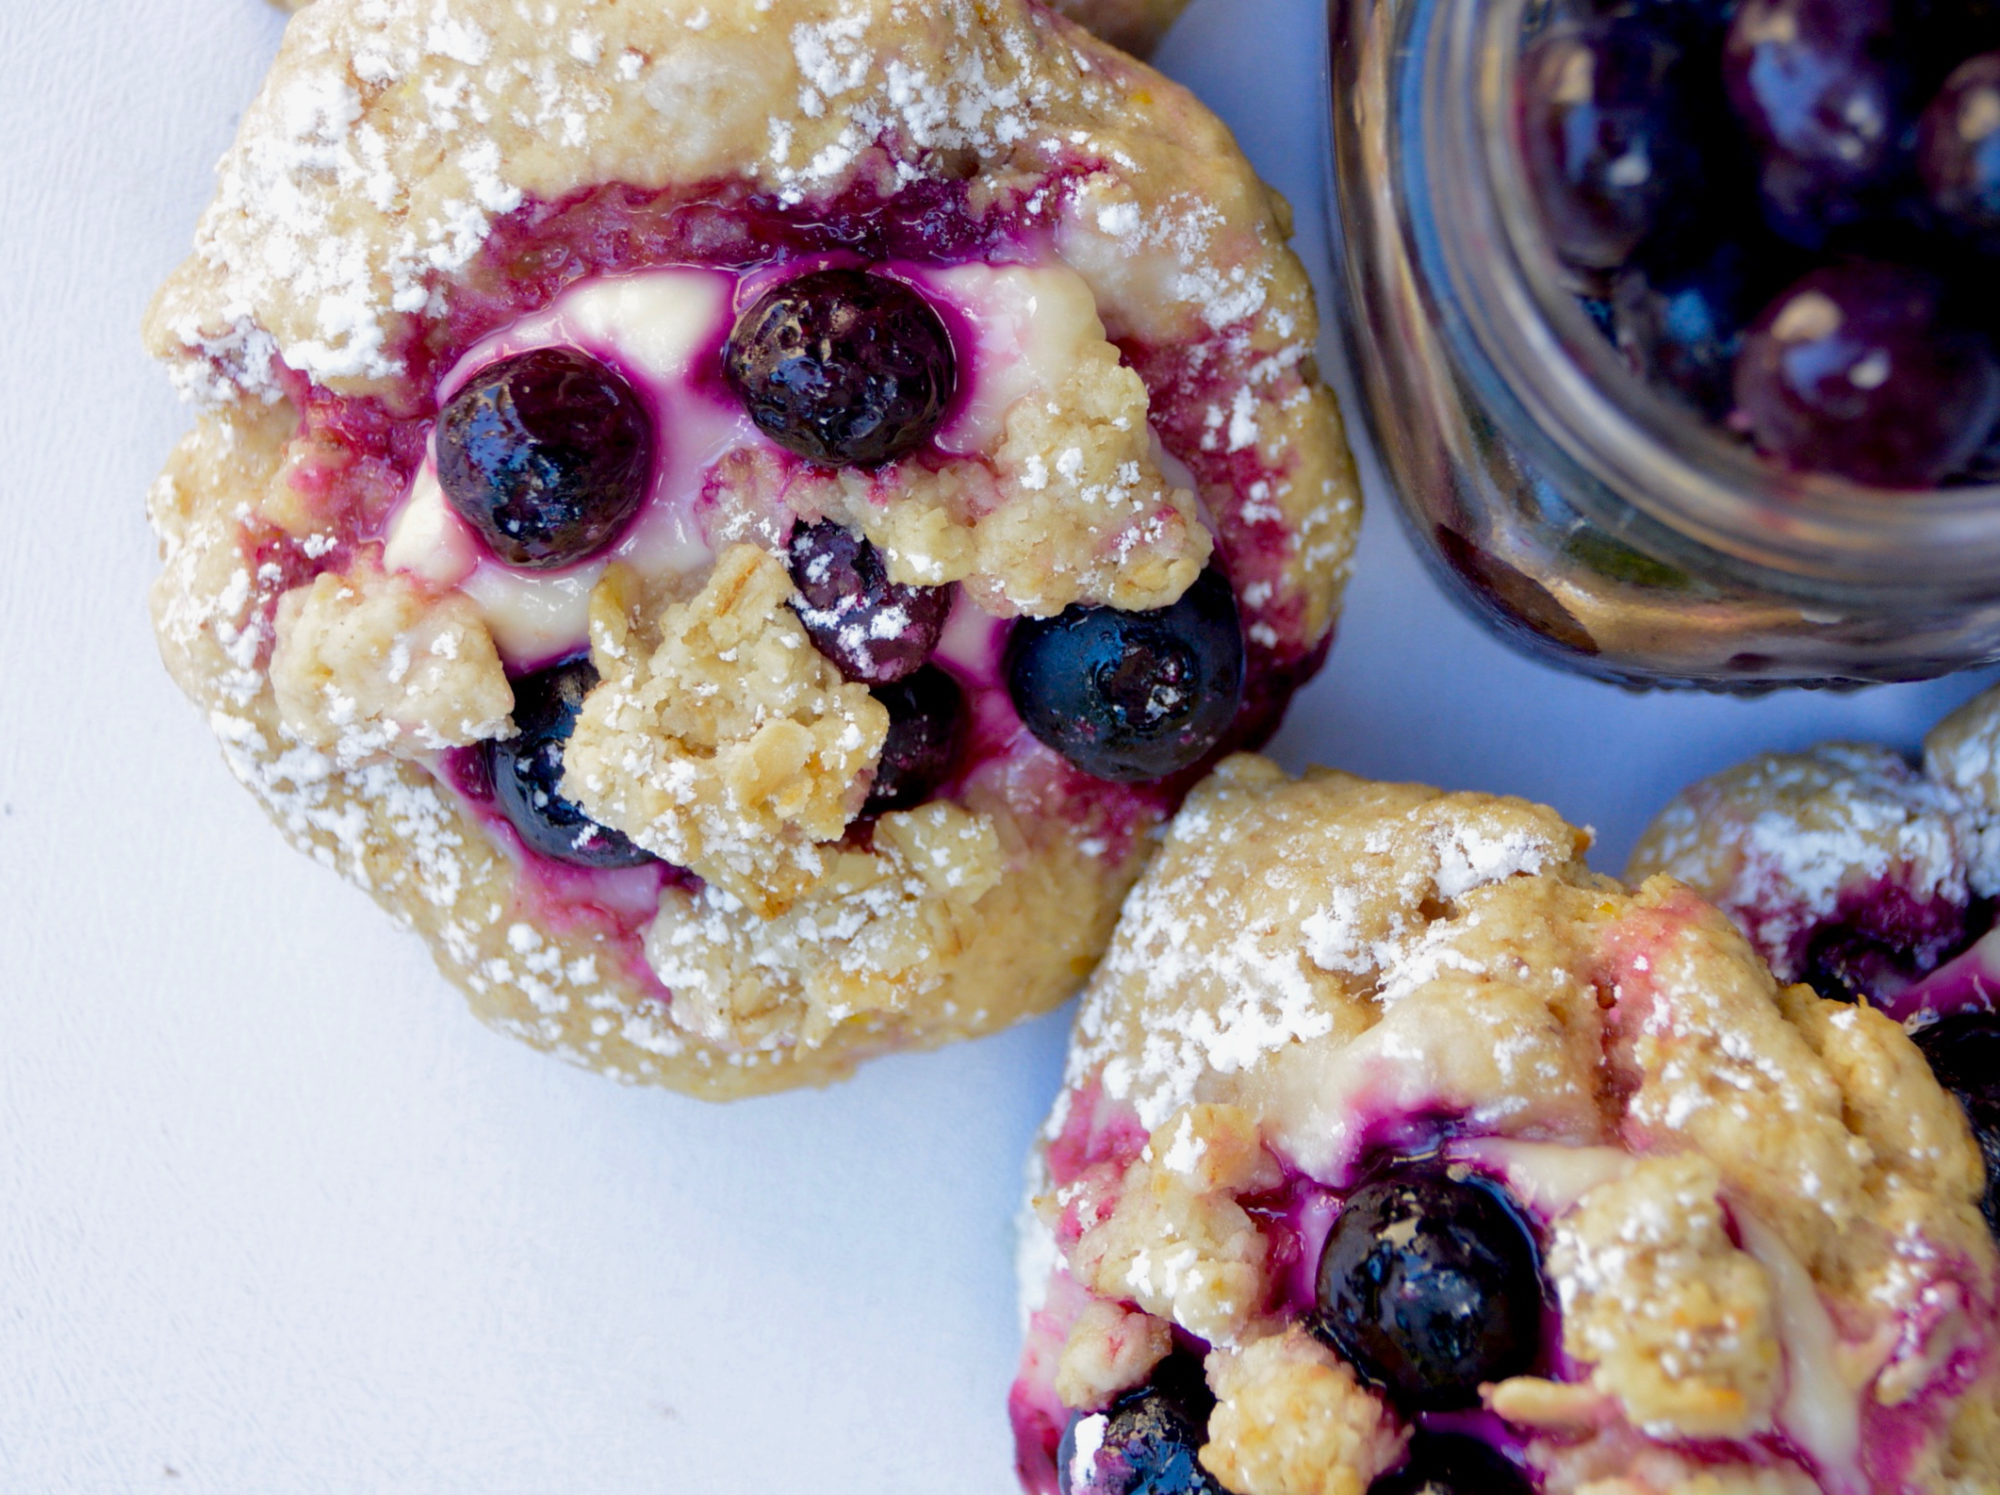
438, 348, 652, 572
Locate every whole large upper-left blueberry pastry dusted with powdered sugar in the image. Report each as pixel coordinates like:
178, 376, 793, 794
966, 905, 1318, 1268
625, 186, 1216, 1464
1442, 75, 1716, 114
148, 0, 1358, 1097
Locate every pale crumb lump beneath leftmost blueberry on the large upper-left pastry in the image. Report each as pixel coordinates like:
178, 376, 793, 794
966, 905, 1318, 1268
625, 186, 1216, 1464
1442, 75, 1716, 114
270, 560, 514, 767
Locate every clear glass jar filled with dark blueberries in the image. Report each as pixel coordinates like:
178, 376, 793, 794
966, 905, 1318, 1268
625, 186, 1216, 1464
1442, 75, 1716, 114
1328, 0, 2000, 692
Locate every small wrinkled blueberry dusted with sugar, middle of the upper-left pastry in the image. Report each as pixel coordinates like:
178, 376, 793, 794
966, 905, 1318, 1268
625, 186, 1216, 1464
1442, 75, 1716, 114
788, 520, 952, 686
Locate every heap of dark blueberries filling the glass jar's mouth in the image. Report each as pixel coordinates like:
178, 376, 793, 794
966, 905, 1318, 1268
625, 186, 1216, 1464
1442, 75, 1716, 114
1518, 0, 2000, 488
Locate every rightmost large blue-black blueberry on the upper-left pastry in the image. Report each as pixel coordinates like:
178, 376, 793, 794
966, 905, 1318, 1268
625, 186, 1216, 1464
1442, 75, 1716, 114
1006, 570, 1244, 783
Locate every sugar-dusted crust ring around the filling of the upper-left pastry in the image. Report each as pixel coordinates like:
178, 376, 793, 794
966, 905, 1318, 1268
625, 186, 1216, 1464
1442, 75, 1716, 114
148, 0, 1358, 1095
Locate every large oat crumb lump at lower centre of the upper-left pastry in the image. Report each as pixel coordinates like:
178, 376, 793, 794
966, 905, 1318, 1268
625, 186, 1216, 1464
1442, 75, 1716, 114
562, 546, 888, 917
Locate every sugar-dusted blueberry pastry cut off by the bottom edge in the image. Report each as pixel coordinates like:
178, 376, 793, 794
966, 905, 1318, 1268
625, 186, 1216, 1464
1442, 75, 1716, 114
1012, 755, 2000, 1495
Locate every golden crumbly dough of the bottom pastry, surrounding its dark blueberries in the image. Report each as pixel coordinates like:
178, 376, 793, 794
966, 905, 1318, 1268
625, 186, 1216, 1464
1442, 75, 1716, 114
1018, 757, 2000, 1495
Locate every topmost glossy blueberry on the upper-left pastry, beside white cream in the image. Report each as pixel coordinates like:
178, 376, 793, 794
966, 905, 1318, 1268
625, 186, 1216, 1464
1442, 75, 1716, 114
722, 270, 958, 468
